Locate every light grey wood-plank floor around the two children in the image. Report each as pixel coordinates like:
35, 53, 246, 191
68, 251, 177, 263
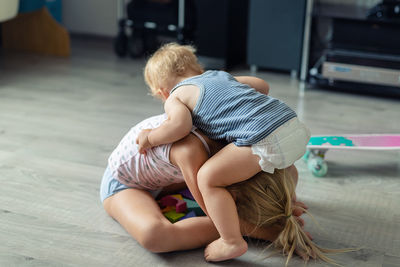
0, 40, 400, 267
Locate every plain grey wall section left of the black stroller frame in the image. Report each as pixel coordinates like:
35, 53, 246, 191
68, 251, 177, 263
62, 0, 118, 37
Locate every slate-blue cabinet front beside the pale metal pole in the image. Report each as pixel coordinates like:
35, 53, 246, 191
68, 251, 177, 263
247, 0, 307, 76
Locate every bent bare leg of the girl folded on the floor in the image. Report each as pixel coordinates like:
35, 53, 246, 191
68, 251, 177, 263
103, 189, 219, 252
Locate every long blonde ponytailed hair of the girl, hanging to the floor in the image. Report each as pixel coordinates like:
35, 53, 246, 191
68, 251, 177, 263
227, 170, 351, 266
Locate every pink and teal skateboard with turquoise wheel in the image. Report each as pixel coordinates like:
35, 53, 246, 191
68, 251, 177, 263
303, 134, 400, 177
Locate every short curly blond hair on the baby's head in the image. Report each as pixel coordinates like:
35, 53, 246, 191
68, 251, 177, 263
144, 43, 204, 95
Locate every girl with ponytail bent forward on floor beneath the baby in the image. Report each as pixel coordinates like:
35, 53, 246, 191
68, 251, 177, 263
100, 114, 339, 263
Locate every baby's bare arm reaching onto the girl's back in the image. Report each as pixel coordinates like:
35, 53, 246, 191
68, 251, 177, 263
136, 96, 192, 153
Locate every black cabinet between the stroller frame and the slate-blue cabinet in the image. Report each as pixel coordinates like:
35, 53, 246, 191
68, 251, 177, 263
194, 0, 249, 69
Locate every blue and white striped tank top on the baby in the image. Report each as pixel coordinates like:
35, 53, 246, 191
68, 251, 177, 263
171, 71, 297, 146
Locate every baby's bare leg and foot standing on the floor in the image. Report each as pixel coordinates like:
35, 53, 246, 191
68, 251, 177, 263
198, 144, 261, 261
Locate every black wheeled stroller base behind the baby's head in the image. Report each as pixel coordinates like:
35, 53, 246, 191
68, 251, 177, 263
114, 0, 196, 58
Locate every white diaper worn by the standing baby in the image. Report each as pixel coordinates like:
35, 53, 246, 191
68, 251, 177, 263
251, 117, 311, 173
